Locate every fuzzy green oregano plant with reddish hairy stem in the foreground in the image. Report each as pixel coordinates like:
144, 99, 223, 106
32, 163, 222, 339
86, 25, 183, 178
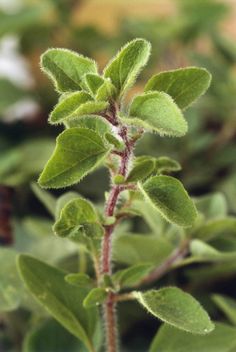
18, 39, 214, 352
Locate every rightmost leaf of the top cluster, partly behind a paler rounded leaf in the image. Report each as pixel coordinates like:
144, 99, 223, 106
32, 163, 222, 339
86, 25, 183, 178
144, 67, 211, 109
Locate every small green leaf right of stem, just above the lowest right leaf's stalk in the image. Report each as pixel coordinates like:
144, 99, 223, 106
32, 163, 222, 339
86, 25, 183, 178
112, 264, 154, 287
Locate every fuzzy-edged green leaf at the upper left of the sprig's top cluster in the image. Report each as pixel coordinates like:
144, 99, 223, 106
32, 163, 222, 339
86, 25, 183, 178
41, 49, 97, 93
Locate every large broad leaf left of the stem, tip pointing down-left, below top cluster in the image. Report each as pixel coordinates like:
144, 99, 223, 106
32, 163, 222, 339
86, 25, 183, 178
39, 127, 107, 188
